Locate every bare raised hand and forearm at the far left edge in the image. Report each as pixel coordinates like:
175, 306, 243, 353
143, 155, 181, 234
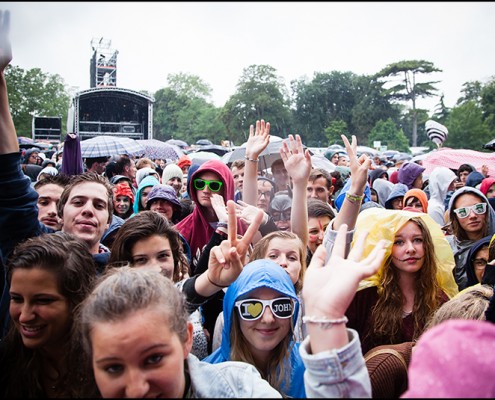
0, 10, 19, 154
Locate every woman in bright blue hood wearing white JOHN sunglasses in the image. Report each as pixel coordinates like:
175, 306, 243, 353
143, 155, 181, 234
204, 259, 306, 398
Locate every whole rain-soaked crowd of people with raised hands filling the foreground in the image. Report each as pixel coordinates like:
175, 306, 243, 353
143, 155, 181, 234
0, 7, 495, 398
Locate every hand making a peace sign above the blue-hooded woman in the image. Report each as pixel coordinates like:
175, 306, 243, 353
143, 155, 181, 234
205, 200, 263, 287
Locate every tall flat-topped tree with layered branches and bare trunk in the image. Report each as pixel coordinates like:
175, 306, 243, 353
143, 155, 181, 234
376, 60, 442, 147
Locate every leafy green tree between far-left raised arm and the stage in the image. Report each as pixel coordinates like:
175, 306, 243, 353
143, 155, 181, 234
5, 65, 70, 137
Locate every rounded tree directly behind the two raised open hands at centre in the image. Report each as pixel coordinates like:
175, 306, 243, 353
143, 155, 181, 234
221, 65, 291, 141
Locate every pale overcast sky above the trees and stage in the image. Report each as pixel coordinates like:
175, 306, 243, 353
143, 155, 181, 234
0, 2, 495, 115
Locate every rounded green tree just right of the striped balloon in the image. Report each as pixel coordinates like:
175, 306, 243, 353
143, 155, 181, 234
444, 101, 493, 151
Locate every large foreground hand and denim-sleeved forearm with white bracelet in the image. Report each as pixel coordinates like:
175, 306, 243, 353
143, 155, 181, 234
299, 224, 385, 398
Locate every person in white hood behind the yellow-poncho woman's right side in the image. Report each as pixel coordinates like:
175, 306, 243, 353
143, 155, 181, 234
428, 167, 457, 226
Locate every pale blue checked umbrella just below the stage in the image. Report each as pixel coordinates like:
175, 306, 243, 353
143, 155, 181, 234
81, 136, 145, 158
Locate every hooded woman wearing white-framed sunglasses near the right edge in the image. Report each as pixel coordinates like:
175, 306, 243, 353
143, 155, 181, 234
447, 186, 495, 290
